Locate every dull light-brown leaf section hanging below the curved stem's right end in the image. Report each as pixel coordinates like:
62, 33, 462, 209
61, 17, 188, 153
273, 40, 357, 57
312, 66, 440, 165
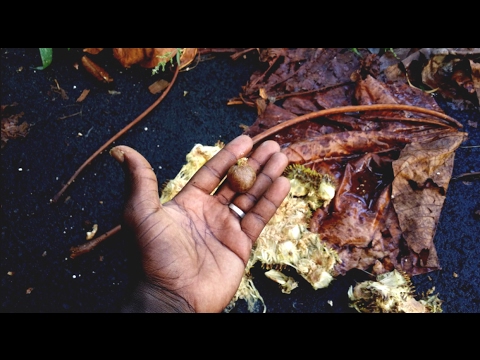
392, 131, 466, 273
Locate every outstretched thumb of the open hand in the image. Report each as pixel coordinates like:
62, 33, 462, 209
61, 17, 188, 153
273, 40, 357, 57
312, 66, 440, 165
110, 145, 161, 229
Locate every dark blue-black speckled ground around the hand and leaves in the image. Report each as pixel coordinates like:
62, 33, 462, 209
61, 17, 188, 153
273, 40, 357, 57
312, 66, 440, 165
0, 48, 480, 313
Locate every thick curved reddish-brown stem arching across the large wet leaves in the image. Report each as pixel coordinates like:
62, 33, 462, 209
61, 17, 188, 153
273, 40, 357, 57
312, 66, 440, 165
252, 104, 463, 145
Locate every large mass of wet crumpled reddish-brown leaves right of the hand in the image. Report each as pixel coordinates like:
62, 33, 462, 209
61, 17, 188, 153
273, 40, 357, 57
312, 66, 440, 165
224, 49, 468, 308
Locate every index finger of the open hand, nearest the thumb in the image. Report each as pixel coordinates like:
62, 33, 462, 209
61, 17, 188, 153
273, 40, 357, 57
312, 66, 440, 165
185, 135, 253, 194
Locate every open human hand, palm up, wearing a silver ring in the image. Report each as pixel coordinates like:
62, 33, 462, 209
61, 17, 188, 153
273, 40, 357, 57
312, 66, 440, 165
110, 135, 290, 312
